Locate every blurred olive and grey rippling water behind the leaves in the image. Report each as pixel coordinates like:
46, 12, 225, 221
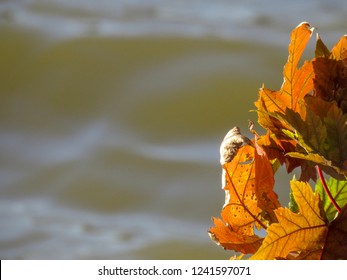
0, 0, 347, 259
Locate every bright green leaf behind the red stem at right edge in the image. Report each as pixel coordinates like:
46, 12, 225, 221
316, 177, 347, 221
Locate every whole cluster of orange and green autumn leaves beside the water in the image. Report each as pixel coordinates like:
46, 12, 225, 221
209, 22, 347, 259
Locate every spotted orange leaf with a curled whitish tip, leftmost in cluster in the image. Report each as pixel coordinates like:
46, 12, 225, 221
209, 131, 280, 254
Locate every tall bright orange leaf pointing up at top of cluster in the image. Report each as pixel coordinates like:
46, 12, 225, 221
255, 22, 314, 147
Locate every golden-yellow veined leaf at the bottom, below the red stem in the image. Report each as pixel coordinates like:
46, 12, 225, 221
251, 181, 327, 259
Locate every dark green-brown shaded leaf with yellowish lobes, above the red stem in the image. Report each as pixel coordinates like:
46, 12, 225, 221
275, 100, 347, 174
